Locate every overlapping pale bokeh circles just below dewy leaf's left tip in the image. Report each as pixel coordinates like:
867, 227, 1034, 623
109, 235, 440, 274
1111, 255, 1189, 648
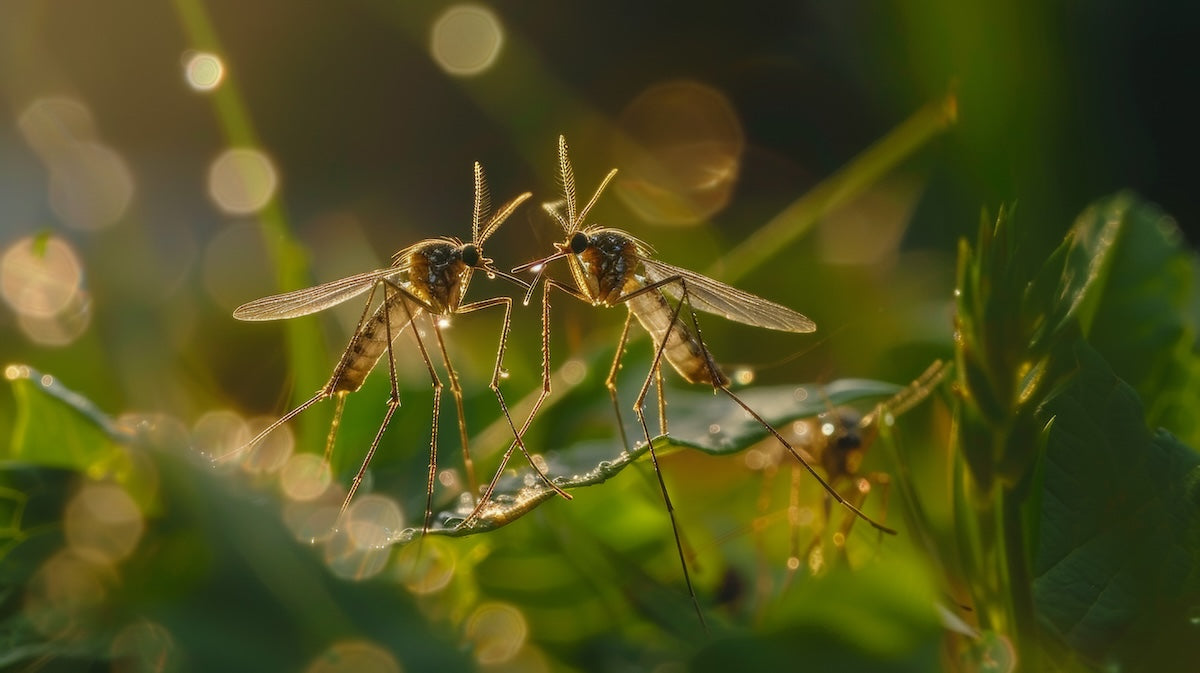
325, 493, 404, 579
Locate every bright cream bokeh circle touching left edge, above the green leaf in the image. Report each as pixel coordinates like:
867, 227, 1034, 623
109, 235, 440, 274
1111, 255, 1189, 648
0, 236, 83, 318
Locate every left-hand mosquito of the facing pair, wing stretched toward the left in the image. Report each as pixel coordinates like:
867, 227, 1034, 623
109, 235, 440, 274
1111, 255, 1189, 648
233, 162, 570, 531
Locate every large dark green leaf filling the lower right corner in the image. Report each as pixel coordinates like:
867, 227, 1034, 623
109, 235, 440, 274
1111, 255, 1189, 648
1033, 342, 1200, 671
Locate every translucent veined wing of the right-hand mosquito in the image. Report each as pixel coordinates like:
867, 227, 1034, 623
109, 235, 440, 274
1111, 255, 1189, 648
642, 257, 817, 332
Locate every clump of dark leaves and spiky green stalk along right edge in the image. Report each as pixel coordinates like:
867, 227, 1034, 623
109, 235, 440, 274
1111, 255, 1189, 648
955, 194, 1200, 671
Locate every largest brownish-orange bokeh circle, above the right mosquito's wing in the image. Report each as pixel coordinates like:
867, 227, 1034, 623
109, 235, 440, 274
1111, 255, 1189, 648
613, 80, 745, 226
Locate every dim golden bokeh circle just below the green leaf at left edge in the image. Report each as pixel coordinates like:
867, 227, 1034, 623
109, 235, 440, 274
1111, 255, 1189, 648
62, 483, 145, 564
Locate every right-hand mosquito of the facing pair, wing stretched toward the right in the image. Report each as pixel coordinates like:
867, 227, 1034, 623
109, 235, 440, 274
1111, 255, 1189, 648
468, 136, 895, 624
